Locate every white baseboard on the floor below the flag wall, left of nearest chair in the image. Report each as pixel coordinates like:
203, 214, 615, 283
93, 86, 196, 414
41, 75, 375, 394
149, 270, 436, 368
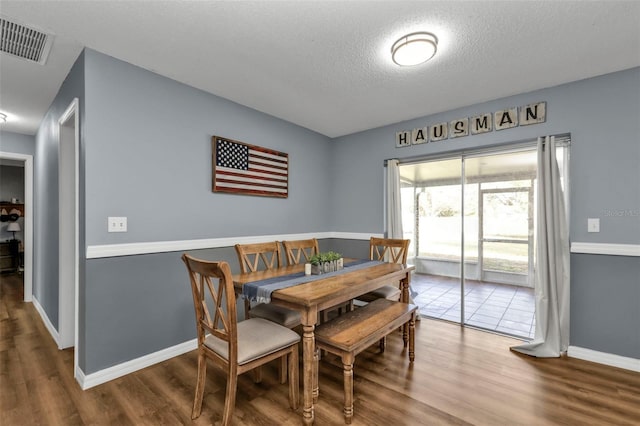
76, 339, 198, 390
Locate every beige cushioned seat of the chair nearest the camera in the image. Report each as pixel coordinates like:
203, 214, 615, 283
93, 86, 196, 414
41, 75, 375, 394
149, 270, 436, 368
204, 318, 300, 365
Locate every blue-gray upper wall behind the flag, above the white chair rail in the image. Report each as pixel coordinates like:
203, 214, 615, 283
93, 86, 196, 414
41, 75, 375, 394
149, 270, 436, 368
85, 50, 331, 245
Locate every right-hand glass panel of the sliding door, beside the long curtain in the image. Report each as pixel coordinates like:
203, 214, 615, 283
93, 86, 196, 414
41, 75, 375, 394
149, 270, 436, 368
462, 148, 537, 338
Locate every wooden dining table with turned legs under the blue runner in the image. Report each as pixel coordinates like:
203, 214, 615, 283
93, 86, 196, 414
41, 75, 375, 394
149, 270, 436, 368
233, 262, 414, 424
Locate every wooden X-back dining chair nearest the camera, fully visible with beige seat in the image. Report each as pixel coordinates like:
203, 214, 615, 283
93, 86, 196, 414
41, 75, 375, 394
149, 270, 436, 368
182, 254, 300, 426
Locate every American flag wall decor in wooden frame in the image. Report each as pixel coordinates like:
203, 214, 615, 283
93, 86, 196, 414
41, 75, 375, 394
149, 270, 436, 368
211, 136, 289, 198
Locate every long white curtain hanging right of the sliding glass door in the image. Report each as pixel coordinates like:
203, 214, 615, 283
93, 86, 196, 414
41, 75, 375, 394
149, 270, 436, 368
511, 136, 569, 357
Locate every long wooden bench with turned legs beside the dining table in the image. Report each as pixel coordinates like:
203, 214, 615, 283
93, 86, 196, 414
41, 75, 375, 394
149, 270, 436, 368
314, 299, 418, 424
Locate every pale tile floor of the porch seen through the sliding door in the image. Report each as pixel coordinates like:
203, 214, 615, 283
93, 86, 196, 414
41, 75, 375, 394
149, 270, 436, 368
411, 274, 535, 339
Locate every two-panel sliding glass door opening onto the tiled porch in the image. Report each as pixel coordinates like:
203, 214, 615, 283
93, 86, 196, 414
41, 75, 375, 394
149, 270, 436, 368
400, 144, 566, 338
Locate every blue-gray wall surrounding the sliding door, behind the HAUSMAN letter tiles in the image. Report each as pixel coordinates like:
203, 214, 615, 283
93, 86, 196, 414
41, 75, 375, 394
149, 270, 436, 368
330, 68, 640, 358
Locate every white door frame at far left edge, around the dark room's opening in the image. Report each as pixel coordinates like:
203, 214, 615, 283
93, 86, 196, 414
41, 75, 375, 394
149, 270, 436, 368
0, 151, 33, 302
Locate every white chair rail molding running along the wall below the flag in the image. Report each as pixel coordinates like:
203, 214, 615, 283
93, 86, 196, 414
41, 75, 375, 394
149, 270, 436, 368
86, 232, 382, 259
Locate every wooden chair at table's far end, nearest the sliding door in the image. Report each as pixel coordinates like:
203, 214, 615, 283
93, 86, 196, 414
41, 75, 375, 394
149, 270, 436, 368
357, 237, 411, 302
